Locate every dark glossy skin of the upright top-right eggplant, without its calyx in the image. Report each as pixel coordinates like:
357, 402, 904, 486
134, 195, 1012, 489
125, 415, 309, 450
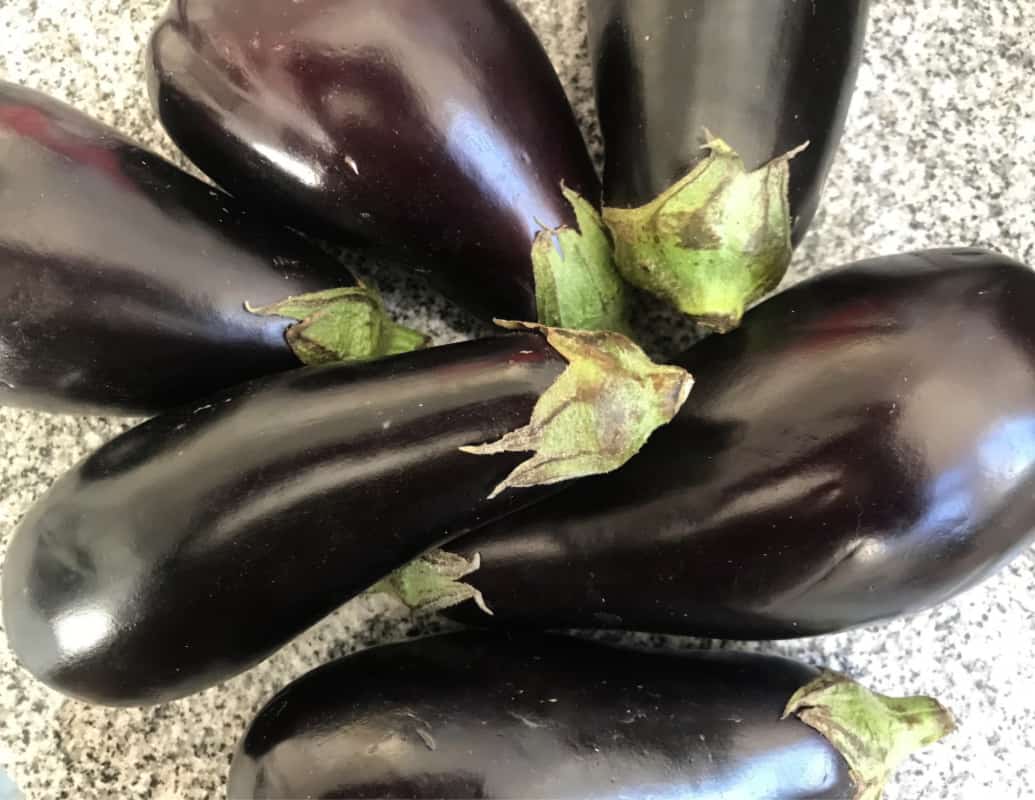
587, 0, 868, 241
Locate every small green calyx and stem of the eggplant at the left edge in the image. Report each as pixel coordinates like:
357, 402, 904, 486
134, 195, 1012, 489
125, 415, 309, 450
244, 284, 428, 366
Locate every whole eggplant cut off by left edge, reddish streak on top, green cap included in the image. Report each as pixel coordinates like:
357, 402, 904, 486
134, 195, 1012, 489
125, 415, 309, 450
0, 83, 426, 414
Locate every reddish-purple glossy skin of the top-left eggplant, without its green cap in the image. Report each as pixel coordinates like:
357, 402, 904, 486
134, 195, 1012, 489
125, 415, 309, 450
148, 0, 600, 321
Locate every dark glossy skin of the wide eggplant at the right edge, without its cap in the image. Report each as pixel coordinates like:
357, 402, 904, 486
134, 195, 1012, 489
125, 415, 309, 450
448, 249, 1035, 639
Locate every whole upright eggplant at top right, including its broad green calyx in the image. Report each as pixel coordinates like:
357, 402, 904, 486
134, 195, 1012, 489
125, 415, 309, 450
587, 0, 868, 331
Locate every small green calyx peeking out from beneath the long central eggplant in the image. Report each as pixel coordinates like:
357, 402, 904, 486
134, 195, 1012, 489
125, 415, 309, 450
366, 550, 493, 615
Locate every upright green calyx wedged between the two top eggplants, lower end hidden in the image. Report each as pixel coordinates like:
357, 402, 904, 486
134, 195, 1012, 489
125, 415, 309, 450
532, 184, 628, 333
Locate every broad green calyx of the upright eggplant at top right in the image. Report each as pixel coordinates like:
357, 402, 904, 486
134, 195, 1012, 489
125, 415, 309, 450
603, 136, 808, 332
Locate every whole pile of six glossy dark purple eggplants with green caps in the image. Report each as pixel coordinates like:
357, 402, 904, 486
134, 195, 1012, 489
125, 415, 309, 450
0, 0, 1035, 800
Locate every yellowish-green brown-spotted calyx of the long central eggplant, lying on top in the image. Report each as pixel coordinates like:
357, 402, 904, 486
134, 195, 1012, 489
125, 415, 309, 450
461, 321, 693, 499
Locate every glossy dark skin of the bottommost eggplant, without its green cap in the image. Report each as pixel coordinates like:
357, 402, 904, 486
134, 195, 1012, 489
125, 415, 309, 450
227, 632, 853, 800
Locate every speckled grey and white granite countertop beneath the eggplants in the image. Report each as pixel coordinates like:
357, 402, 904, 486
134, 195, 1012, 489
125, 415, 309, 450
0, 0, 1035, 800
